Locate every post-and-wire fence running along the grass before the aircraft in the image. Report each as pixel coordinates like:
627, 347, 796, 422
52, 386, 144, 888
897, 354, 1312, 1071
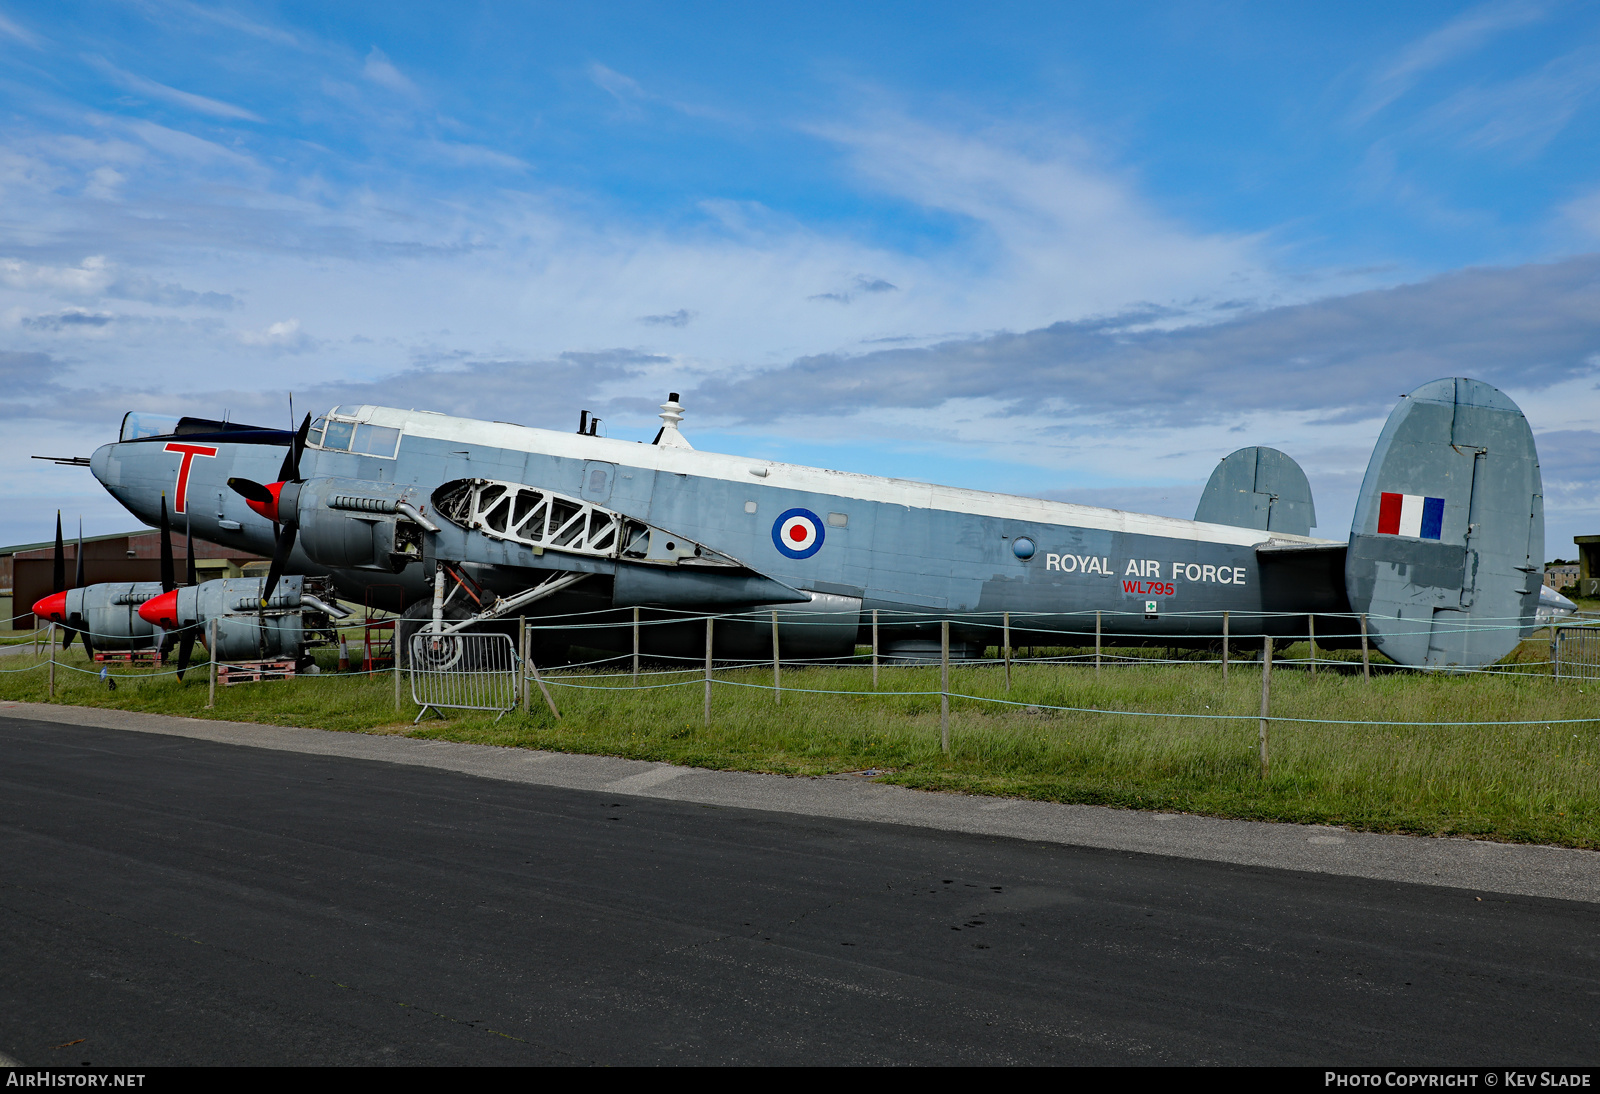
9, 609, 1600, 761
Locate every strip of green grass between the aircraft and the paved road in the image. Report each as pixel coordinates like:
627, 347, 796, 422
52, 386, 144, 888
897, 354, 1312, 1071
0, 643, 1600, 848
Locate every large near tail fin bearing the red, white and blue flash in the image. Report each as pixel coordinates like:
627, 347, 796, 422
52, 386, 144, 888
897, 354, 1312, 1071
1344, 377, 1544, 669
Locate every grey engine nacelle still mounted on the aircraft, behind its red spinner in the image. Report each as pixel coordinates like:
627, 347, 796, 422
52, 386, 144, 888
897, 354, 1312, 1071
278, 478, 438, 574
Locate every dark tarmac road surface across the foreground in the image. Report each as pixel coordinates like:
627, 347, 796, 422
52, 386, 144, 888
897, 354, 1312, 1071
0, 715, 1600, 1065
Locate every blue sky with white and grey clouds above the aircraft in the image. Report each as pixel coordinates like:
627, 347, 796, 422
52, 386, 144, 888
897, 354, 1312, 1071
0, 0, 1600, 557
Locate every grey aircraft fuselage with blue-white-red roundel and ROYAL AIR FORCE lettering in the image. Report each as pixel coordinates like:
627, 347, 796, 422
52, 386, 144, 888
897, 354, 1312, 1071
91, 406, 1347, 658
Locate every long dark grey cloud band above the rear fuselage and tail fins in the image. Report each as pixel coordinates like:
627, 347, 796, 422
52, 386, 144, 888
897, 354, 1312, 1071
696, 256, 1600, 427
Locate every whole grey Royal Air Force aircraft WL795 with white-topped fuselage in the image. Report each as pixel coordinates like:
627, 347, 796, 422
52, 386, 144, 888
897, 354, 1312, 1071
56, 379, 1544, 667
